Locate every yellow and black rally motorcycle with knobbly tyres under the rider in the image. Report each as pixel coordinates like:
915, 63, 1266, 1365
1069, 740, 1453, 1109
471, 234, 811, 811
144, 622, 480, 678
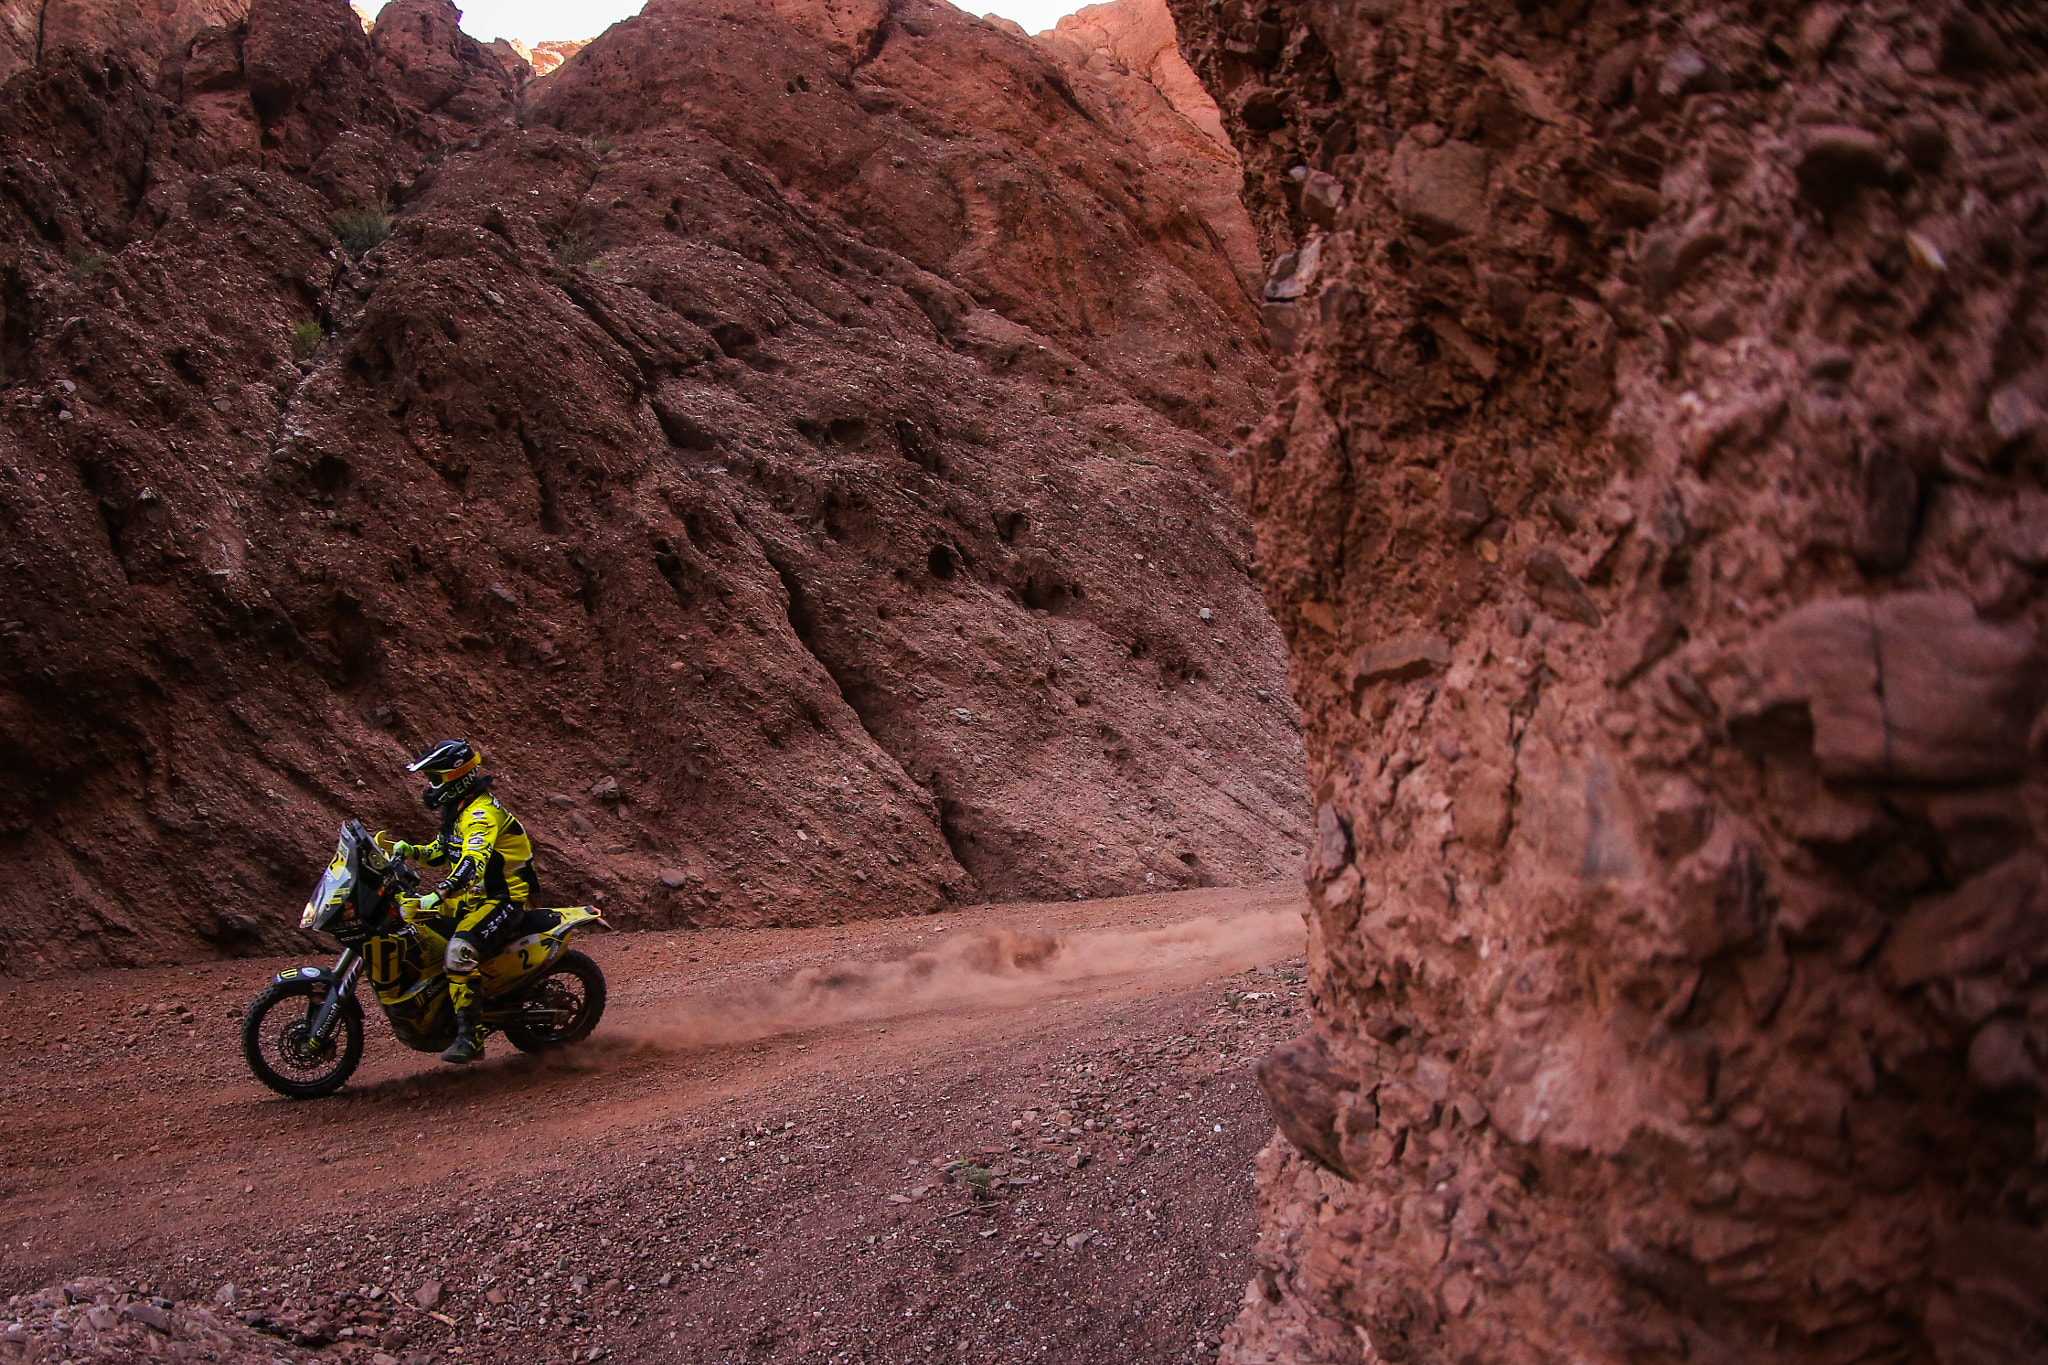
242, 821, 604, 1099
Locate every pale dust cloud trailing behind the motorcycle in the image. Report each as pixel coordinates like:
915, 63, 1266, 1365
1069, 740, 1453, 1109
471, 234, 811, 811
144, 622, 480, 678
621, 907, 1303, 1050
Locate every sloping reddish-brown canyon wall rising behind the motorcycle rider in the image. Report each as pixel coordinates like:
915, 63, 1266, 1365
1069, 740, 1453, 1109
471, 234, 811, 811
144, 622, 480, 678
0, 0, 1307, 972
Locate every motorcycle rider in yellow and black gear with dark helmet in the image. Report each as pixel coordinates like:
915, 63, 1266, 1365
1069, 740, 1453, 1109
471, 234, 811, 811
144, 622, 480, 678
391, 739, 539, 1062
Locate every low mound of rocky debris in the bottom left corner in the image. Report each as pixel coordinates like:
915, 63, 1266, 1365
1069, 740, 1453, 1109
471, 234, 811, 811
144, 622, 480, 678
0, 1277, 311, 1365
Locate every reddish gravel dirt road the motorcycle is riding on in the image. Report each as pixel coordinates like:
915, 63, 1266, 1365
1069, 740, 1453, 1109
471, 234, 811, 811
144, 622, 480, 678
0, 886, 1303, 1365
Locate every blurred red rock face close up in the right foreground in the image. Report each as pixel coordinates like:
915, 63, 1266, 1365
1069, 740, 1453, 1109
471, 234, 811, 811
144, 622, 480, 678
1174, 0, 2048, 1365
